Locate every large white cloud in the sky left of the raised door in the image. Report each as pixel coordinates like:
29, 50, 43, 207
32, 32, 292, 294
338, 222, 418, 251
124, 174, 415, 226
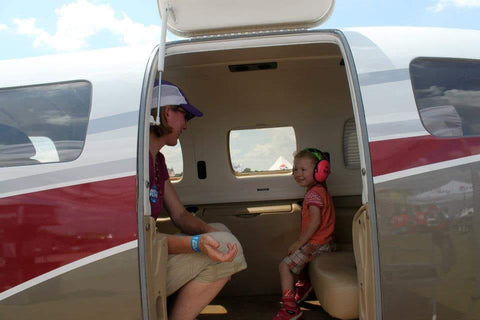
13, 0, 165, 51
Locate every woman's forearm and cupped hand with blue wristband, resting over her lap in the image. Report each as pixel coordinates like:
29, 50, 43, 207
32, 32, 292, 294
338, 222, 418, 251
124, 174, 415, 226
166, 234, 238, 262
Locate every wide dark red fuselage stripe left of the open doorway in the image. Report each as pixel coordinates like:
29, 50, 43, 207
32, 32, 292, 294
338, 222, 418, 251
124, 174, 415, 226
0, 176, 137, 292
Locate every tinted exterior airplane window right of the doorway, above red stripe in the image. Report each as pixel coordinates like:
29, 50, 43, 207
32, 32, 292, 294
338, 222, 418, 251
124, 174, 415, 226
410, 58, 480, 137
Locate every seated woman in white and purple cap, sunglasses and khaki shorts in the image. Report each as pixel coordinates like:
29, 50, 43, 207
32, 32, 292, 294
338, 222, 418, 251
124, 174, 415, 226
150, 81, 247, 320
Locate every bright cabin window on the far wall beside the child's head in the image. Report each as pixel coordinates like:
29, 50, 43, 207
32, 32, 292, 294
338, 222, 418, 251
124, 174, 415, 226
229, 127, 297, 176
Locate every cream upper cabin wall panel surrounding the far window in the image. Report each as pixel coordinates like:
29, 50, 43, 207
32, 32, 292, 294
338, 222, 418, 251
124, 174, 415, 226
165, 44, 361, 204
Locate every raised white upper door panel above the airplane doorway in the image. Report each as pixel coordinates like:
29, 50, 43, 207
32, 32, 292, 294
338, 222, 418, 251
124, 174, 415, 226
158, 0, 335, 37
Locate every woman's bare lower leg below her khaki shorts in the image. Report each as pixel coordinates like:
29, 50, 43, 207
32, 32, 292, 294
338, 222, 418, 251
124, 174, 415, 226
168, 277, 230, 320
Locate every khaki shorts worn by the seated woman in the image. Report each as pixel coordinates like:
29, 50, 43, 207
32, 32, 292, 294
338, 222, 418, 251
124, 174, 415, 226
167, 223, 247, 295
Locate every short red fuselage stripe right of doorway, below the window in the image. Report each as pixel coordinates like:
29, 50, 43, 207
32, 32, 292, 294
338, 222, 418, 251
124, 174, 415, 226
369, 136, 480, 177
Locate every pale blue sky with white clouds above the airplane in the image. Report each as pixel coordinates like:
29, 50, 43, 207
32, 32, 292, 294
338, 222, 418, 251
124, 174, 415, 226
0, 0, 480, 60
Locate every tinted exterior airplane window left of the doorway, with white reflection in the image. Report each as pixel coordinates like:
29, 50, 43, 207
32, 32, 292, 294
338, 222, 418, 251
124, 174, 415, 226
0, 81, 92, 167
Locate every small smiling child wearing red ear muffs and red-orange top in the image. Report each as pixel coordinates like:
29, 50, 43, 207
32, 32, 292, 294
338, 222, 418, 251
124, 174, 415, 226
274, 148, 335, 320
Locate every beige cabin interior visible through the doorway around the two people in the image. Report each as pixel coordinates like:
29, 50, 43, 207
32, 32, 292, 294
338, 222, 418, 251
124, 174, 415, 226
148, 42, 373, 319
